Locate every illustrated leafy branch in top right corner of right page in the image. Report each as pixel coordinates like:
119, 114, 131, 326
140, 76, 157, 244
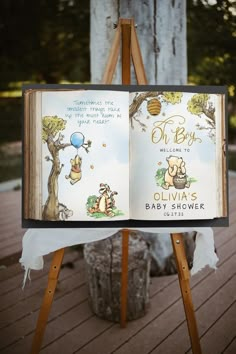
188, 93, 215, 140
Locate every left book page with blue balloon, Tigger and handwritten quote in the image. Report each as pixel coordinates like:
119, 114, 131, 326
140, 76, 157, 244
42, 90, 129, 221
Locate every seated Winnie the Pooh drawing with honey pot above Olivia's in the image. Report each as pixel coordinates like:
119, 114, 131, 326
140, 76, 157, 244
162, 155, 190, 189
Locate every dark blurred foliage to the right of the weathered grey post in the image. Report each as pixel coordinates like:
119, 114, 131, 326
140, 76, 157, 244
187, 0, 236, 143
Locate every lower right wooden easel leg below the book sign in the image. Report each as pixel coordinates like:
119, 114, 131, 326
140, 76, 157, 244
171, 233, 202, 354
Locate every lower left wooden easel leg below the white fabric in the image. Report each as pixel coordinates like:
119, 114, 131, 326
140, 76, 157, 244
31, 248, 65, 354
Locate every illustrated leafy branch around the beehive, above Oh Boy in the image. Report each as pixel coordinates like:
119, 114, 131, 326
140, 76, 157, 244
129, 91, 182, 131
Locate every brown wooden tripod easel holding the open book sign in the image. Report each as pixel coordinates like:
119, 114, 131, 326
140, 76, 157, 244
31, 19, 202, 354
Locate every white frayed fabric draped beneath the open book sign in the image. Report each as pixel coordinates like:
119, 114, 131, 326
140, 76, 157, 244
20, 228, 218, 286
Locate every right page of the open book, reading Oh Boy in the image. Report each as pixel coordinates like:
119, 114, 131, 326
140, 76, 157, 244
130, 91, 225, 220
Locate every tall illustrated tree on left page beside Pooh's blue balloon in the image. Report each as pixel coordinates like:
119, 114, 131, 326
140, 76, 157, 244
42, 116, 71, 221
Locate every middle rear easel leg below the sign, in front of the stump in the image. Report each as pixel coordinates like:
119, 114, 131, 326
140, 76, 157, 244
120, 229, 129, 328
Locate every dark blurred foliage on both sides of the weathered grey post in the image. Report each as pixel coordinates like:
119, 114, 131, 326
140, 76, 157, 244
0, 0, 236, 182
